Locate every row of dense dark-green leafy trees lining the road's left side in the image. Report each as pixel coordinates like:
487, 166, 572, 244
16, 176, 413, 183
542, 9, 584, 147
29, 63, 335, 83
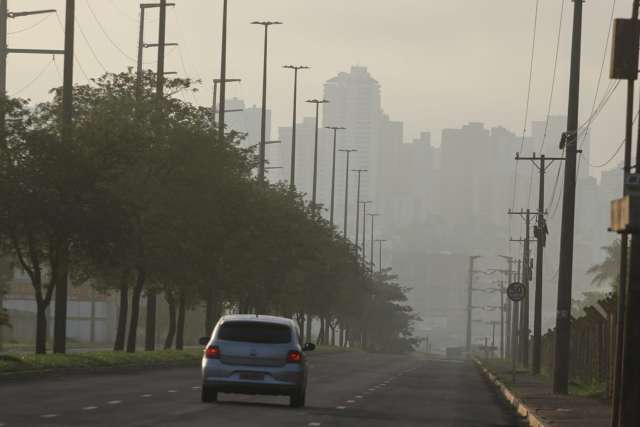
0, 71, 415, 360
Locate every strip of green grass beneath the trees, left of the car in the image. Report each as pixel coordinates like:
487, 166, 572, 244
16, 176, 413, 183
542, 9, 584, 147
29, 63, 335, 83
0, 350, 202, 374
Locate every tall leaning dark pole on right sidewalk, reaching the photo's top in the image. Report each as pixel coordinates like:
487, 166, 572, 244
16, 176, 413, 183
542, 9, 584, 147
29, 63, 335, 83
553, 0, 583, 394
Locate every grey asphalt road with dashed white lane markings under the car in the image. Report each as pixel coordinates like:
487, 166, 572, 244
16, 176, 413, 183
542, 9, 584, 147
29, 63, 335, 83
0, 353, 519, 427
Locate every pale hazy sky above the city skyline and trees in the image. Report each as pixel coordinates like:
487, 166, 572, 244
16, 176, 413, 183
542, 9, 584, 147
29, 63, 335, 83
8, 0, 631, 177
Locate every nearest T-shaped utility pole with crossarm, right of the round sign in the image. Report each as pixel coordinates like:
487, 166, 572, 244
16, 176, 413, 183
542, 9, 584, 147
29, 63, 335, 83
516, 153, 564, 375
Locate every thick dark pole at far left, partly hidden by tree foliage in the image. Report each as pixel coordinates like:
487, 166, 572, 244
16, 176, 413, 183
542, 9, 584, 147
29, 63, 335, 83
53, 0, 76, 353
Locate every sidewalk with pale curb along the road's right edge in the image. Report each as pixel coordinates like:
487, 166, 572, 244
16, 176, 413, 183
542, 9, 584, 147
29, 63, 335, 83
476, 360, 611, 427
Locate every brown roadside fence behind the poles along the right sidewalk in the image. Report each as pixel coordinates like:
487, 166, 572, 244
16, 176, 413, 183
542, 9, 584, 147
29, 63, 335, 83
542, 297, 617, 396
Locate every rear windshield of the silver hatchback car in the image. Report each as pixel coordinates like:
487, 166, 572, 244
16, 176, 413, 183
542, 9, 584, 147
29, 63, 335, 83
218, 321, 291, 344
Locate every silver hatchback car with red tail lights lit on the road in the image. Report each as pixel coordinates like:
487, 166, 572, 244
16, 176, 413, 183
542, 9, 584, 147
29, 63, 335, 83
200, 314, 315, 408
